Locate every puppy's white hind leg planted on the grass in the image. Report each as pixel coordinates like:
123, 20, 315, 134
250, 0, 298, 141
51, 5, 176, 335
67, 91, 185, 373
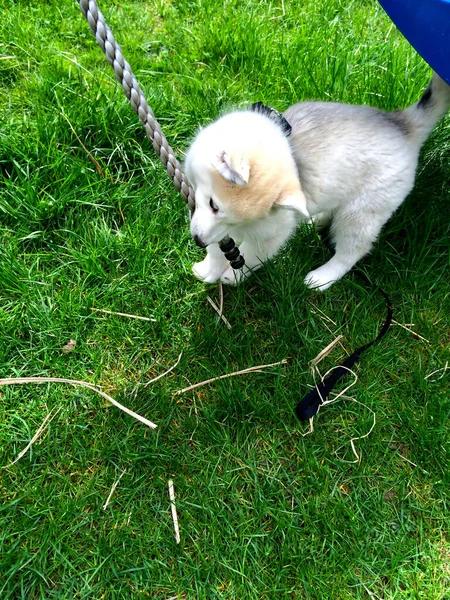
305, 205, 391, 291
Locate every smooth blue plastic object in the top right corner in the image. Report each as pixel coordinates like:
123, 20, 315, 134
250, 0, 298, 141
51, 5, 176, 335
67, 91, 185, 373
378, 0, 450, 84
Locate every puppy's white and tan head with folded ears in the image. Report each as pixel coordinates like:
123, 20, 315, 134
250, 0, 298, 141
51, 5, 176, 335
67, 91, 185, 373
185, 111, 308, 246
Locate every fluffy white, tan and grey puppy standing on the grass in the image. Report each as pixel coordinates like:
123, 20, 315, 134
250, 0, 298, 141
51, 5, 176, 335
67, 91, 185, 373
185, 74, 450, 290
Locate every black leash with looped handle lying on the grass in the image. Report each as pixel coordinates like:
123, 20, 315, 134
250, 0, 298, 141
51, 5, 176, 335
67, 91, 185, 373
295, 251, 393, 421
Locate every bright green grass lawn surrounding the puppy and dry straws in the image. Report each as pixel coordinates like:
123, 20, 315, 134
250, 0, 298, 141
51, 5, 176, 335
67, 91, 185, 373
0, 0, 450, 600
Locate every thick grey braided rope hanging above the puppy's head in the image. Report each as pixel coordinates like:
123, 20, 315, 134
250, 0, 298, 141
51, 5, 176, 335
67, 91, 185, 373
79, 0, 195, 210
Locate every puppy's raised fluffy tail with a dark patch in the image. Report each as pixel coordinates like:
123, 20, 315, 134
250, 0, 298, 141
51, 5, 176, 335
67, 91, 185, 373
404, 73, 450, 145
